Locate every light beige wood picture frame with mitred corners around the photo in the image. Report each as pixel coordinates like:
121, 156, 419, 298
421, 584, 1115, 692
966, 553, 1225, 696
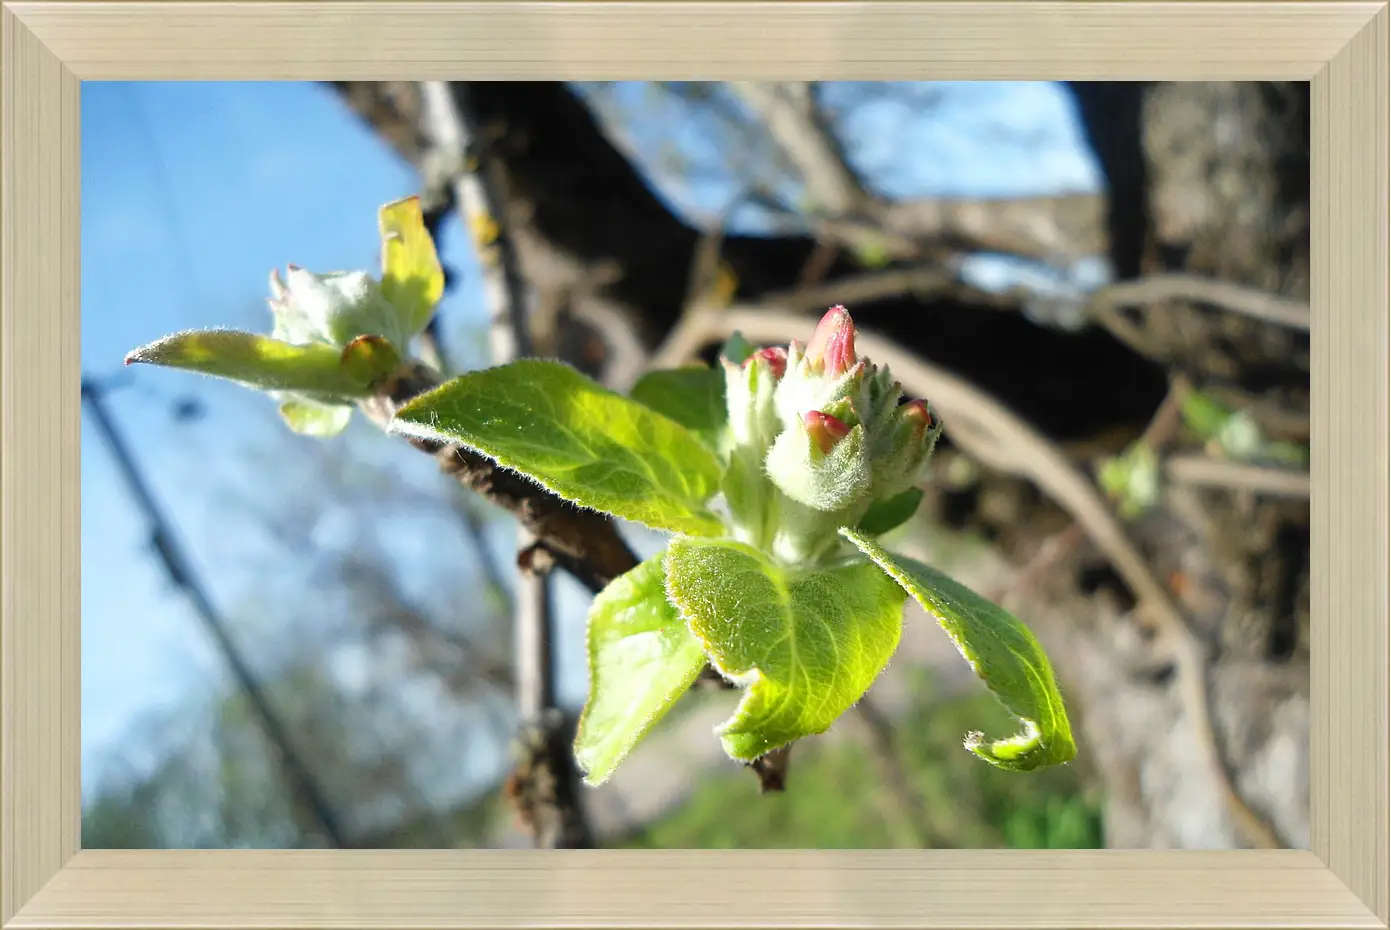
0, 0, 1391, 929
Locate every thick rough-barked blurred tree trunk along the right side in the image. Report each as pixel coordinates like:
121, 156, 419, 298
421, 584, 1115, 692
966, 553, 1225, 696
1061, 83, 1309, 847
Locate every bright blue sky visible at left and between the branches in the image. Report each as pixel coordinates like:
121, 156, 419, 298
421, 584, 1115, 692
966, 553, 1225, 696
82, 82, 1097, 806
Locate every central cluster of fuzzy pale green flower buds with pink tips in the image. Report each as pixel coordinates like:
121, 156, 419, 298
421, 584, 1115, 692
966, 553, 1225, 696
722, 306, 942, 562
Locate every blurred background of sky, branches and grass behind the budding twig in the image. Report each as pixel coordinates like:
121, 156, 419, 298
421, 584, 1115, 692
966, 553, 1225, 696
82, 82, 1309, 848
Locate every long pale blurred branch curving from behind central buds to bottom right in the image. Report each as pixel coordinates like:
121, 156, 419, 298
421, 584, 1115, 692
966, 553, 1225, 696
659, 307, 1281, 849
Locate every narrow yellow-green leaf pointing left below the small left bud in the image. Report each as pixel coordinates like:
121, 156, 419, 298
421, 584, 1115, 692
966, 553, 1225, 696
125, 329, 369, 400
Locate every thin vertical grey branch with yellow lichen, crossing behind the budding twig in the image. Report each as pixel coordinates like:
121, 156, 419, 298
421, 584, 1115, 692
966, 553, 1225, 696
420, 81, 593, 848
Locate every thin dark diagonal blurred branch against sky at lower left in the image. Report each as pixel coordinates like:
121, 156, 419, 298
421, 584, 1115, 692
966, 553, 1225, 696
82, 378, 348, 848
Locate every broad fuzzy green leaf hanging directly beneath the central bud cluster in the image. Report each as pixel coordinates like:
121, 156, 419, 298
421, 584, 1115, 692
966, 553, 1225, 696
666, 539, 904, 762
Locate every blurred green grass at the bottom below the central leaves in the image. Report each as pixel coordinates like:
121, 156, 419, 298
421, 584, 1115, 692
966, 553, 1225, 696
613, 675, 1103, 849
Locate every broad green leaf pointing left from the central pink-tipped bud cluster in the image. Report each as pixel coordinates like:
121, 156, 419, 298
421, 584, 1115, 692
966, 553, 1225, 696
392, 359, 723, 537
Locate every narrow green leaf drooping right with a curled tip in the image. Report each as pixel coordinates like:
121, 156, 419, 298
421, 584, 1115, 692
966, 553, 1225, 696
840, 528, 1077, 772
